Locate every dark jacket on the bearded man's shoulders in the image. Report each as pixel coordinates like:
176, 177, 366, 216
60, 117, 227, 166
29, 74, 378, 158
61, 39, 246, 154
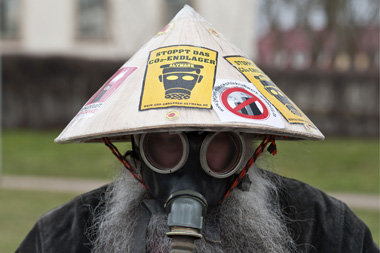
16, 175, 380, 253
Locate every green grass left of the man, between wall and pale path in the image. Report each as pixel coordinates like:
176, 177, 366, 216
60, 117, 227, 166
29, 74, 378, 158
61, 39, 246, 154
3, 130, 129, 179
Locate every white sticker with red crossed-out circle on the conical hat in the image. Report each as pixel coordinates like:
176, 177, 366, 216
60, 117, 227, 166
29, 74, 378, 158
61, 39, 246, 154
212, 79, 284, 128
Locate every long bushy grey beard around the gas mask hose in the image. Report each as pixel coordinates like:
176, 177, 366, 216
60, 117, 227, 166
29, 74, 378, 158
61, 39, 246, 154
93, 169, 295, 253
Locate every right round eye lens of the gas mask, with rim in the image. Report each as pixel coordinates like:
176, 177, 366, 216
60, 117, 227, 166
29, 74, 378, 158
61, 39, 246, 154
201, 132, 243, 178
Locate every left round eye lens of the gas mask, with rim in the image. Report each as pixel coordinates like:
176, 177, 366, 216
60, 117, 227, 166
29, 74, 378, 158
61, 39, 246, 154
140, 133, 188, 174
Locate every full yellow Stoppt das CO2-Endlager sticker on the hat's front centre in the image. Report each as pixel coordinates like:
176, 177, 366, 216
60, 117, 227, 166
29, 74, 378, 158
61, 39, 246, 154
140, 45, 218, 111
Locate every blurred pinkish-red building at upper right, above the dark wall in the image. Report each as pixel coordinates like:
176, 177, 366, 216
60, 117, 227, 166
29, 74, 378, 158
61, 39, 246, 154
257, 26, 380, 72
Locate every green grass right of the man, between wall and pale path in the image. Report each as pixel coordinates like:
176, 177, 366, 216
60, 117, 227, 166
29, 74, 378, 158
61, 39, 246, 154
259, 138, 379, 194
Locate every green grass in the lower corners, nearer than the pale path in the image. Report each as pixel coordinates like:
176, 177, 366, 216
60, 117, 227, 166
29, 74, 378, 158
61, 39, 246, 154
0, 189, 379, 252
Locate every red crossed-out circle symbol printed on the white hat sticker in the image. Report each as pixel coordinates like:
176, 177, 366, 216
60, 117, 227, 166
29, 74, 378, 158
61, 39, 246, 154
221, 87, 269, 119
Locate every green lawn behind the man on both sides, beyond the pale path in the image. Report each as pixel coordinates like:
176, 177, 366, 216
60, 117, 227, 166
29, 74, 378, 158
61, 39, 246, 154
3, 130, 379, 194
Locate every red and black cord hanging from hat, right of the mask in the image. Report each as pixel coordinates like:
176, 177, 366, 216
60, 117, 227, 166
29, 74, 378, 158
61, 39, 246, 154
219, 135, 277, 204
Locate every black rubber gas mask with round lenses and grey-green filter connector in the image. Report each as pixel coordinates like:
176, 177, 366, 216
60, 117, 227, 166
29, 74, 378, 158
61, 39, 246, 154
134, 132, 251, 250
